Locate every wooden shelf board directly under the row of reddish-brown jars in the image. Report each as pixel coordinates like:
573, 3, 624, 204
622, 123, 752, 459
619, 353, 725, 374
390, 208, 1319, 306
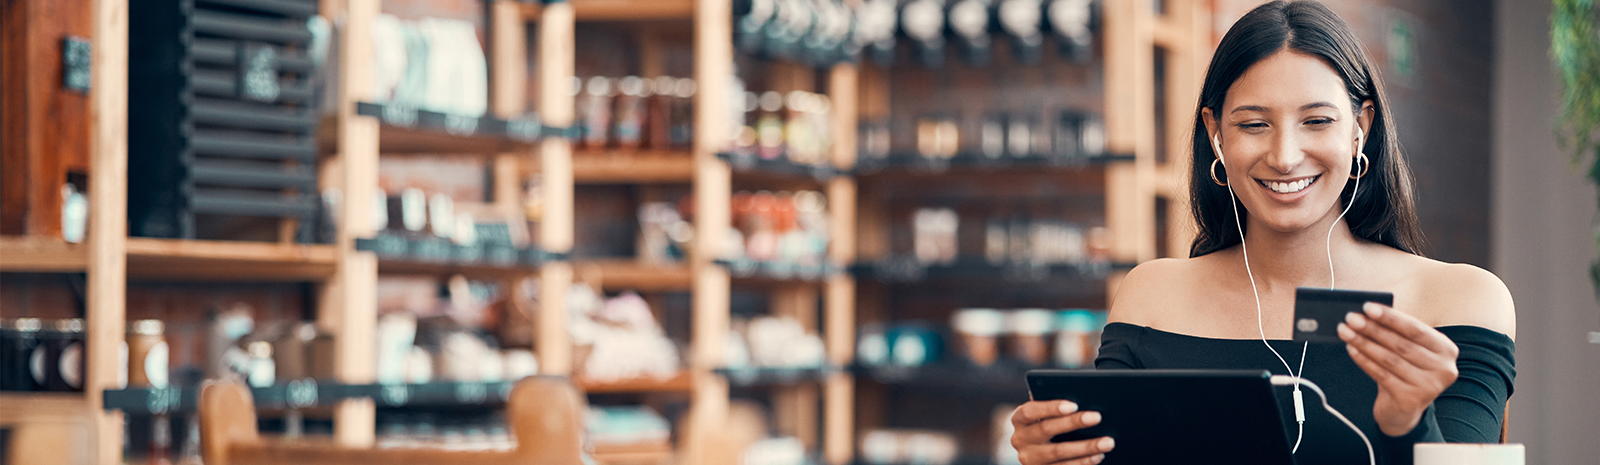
573, 150, 694, 184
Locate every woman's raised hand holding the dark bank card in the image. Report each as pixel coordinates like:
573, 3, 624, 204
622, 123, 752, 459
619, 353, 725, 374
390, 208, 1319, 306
1339, 302, 1461, 436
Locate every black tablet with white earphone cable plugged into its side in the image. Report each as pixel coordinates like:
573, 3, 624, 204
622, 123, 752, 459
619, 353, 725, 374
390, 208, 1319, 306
1027, 369, 1294, 465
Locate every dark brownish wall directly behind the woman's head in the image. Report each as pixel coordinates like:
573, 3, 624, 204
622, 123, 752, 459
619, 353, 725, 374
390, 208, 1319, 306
1213, 0, 1494, 267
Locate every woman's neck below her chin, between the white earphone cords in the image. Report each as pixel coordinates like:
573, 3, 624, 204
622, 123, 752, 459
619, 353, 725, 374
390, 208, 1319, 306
1245, 211, 1358, 292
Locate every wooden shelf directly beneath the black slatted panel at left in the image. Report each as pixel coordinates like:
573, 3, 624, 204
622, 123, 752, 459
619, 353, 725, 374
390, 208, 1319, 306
128, 238, 339, 281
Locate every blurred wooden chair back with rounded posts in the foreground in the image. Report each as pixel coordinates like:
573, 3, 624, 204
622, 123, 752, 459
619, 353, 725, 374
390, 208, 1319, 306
200, 377, 586, 465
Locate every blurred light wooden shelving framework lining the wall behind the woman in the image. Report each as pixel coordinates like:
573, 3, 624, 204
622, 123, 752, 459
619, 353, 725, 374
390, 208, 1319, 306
0, 0, 1211, 465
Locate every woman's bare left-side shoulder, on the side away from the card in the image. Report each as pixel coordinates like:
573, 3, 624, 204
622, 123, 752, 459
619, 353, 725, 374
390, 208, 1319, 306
1109, 259, 1205, 328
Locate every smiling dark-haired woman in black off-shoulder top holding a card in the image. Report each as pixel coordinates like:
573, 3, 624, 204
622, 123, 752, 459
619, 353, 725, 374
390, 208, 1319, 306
1011, 2, 1515, 465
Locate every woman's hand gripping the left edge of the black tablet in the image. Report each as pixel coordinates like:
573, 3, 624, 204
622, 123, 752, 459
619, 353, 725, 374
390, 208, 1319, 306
1011, 401, 1115, 465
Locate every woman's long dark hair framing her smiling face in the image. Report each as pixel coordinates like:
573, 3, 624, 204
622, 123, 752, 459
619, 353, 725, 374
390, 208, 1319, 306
1189, 0, 1422, 257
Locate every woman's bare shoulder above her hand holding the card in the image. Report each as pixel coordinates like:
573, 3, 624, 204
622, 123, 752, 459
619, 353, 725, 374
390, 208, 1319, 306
1408, 256, 1517, 339
